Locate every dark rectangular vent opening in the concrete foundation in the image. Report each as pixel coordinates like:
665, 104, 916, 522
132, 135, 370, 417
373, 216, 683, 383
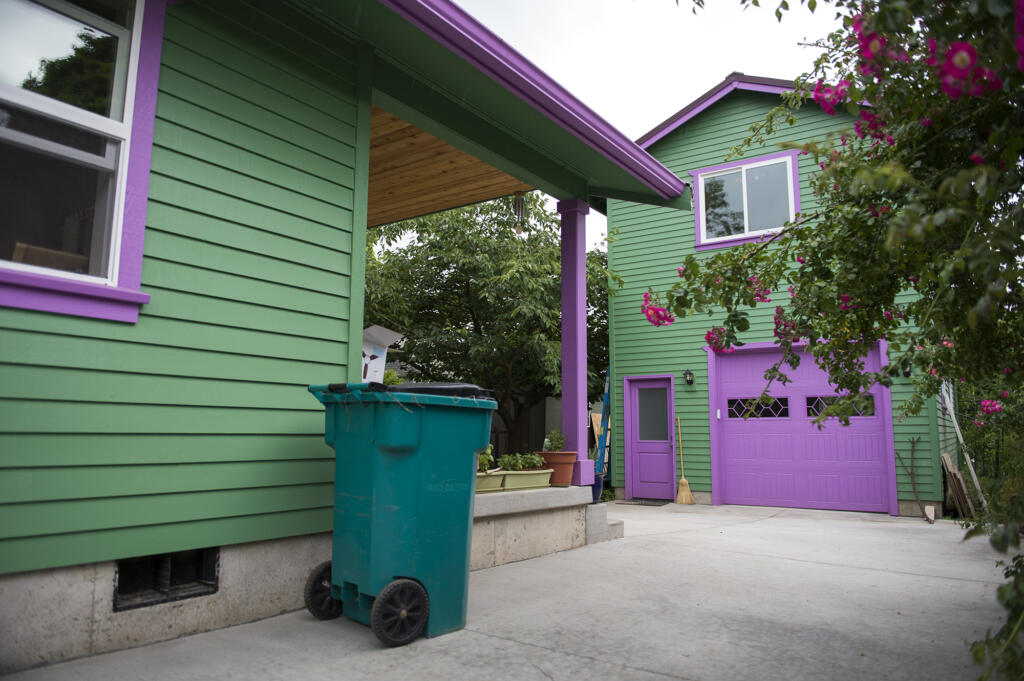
114, 548, 220, 611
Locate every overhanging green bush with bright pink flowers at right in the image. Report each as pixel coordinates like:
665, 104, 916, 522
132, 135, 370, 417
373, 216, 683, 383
645, 0, 1024, 678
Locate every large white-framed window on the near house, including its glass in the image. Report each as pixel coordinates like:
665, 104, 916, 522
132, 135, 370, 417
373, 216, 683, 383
0, 0, 142, 287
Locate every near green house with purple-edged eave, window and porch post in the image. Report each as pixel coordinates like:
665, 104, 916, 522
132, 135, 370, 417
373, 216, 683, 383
0, 0, 684, 673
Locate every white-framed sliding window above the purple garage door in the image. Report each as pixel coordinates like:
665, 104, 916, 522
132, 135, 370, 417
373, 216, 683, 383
691, 152, 800, 249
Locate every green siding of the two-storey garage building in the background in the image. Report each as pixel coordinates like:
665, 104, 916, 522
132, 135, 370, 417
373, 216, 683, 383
608, 91, 942, 500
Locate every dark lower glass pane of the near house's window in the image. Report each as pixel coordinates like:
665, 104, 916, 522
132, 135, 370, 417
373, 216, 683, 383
0, 138, 114, 276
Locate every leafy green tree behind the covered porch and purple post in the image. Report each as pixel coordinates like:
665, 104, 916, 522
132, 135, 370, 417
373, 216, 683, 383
366, 194, 617, 451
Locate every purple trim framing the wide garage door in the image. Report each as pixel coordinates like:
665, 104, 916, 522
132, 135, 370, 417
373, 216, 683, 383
704, 340, 899, 515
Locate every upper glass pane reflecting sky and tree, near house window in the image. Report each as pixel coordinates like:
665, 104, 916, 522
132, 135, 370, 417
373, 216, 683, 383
0, 0, 118, 116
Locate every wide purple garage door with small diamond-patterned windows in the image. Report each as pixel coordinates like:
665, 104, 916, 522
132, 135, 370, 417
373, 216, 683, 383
712, 351, 894, 512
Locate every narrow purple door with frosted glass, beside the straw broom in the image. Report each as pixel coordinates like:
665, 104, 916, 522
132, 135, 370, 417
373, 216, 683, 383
625, 376, 677, 499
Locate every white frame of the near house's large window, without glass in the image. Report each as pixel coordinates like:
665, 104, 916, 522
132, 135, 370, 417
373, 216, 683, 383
0, 0, 145, 288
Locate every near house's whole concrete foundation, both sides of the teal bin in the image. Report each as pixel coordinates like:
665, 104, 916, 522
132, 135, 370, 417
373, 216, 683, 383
0, 487, 623, 676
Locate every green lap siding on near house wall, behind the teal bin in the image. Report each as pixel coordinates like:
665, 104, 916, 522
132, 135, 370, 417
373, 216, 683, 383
0, 2, 362, 572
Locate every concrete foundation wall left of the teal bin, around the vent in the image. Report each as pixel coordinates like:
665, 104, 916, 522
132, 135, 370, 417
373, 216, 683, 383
0, 534, 331, 675
